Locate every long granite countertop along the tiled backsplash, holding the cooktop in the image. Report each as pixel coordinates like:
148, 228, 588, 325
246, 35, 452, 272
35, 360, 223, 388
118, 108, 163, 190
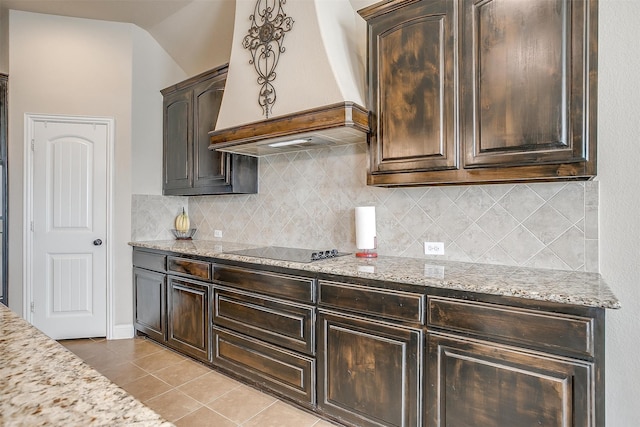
130, 240, 620, 309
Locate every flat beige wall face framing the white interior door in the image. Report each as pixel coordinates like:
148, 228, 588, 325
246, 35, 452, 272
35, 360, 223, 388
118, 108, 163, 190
8, 11, 132, 324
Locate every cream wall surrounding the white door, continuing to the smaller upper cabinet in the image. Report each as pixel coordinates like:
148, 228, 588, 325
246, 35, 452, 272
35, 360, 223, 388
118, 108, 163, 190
9, 11, 185, 336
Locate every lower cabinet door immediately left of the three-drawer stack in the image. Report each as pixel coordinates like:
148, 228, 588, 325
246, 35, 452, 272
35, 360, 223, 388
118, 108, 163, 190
167, 276, 211, 361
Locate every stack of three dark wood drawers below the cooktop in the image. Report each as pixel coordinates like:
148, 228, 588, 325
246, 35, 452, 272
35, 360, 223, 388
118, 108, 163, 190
212, 264, 316, 407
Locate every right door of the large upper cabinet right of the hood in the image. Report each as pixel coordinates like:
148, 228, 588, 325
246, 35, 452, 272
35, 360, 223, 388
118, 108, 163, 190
460, 0, 595, 175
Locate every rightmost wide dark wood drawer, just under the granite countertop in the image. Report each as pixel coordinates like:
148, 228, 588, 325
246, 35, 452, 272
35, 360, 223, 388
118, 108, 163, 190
427, 297, 594, 356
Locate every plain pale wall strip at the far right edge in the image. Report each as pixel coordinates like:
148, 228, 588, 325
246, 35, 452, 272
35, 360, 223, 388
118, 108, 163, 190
598, 0, 640, 427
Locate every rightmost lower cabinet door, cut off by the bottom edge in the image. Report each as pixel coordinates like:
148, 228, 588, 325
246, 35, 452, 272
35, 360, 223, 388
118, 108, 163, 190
426, 334, 595, 427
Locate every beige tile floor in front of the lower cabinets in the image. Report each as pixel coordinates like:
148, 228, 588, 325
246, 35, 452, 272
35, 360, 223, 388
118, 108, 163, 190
60, 338, 333, 427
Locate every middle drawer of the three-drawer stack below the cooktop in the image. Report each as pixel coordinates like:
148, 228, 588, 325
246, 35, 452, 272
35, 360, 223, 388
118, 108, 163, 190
213, 289, 315, 354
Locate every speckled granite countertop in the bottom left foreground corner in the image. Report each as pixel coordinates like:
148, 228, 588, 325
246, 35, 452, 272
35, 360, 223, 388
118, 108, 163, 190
0, 304, 173, 427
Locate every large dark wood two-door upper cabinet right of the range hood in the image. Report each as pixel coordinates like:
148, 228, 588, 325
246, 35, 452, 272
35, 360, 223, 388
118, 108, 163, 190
359, 0, 597, 186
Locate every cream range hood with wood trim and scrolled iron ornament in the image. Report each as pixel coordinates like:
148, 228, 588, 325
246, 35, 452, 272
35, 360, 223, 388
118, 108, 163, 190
209, 0, 370, 156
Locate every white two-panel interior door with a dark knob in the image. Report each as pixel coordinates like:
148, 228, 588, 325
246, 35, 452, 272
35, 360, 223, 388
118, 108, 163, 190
30, 119, 111, 339
